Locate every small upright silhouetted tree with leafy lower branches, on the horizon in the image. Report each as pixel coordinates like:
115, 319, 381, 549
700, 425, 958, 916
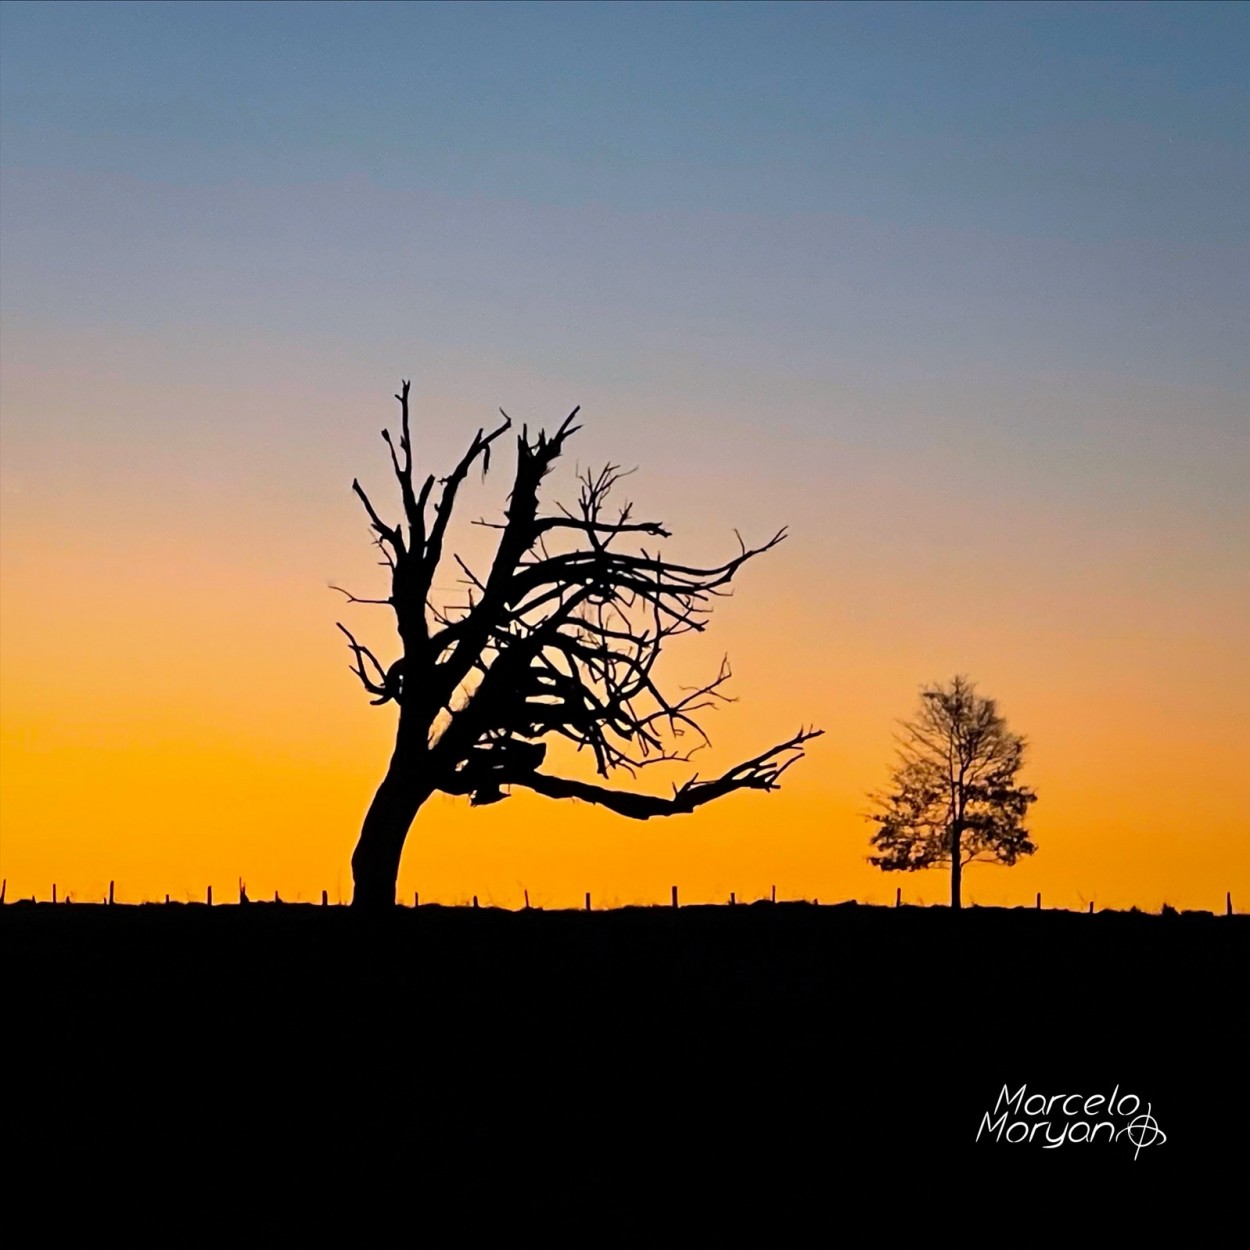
869, 678, 1038, 908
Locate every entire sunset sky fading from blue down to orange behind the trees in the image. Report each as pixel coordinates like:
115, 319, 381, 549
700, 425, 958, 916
0, 0, 1250, 908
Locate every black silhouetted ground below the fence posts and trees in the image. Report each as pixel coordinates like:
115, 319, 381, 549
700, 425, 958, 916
0, 904, 1250, 1220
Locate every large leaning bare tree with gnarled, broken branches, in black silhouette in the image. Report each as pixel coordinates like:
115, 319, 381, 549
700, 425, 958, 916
335, 381, 820, 908
